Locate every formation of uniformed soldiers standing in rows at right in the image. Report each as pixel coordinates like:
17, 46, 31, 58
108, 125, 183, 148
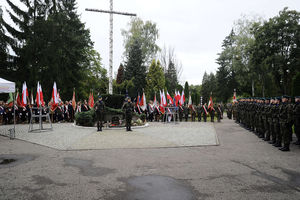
227, 95, 300, 151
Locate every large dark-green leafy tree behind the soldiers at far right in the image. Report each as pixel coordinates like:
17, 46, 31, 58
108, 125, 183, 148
253, 8, 300, 94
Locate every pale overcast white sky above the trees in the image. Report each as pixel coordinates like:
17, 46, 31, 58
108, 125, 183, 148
0, 0, 300, 85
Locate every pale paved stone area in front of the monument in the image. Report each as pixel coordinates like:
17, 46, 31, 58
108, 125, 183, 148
3, 122, 218, 150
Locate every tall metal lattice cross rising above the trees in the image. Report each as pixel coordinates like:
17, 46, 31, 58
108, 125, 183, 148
85, 0, 136, 94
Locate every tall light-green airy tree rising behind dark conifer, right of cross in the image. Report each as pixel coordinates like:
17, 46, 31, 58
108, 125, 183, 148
122, 17, 159, 66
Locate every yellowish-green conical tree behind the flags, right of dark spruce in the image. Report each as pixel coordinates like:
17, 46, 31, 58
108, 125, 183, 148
146, 60, 165, 99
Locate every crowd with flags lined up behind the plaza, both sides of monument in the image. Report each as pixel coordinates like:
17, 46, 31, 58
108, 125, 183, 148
0, 95, 224, 125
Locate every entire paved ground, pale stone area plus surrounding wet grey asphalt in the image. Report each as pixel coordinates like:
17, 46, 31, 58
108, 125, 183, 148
0, 119, 300, 200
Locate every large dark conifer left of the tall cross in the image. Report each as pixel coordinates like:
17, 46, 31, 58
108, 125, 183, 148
3, 0, 92, 100
